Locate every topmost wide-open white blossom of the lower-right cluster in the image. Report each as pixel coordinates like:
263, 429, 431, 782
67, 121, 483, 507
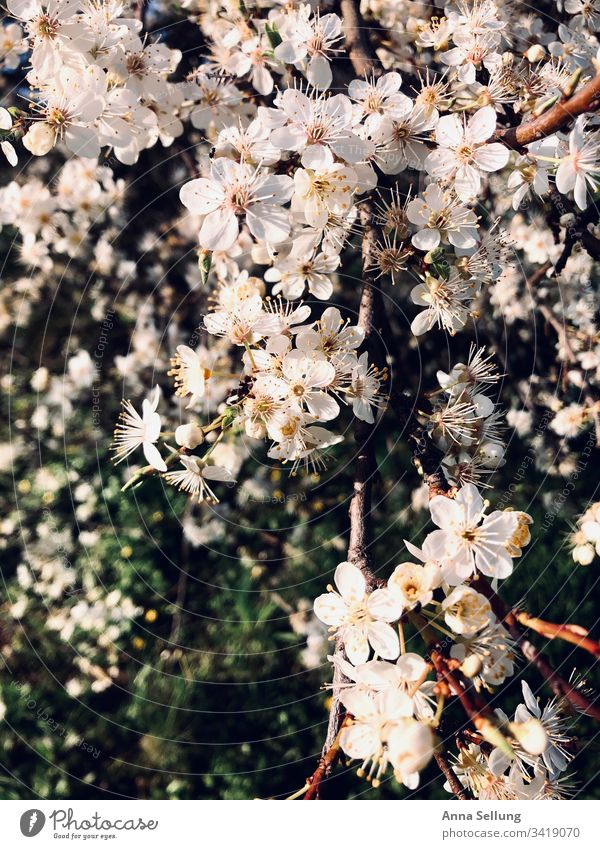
427, 484, 519, 584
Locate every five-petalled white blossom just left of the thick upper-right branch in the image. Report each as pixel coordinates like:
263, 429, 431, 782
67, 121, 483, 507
425, 106, 509, 201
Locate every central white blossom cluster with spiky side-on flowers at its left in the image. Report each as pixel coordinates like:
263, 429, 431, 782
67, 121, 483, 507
114, 298, 385, 501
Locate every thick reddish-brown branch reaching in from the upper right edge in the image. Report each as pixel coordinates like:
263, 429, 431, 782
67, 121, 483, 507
495, 73, 600, 150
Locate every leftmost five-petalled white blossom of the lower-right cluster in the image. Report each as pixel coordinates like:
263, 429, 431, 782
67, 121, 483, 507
314, 562, 402, 665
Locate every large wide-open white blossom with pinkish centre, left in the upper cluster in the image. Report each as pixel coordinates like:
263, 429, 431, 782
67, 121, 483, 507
179, 157, 294, 251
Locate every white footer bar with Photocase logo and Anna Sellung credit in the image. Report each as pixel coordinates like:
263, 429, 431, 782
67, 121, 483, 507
0, 800, 600, 849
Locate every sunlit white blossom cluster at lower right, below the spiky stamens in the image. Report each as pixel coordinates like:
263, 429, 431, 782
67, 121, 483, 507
314, 484, 536, 788
